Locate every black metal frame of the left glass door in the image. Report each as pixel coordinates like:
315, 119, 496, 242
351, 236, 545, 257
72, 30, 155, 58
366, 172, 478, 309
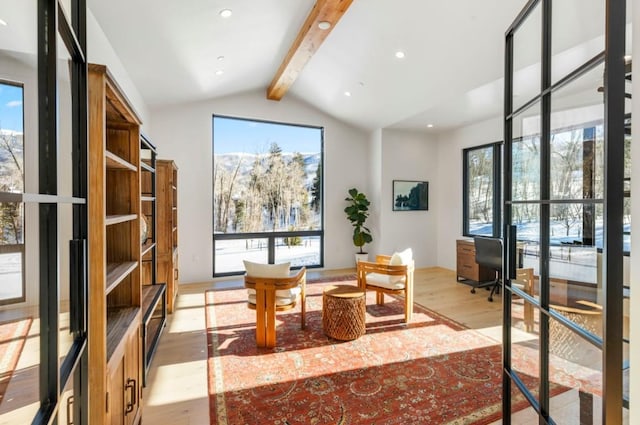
35, 0, 89, 424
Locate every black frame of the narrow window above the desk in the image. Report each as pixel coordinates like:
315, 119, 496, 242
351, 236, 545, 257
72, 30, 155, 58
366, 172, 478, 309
462, 141, 503, 238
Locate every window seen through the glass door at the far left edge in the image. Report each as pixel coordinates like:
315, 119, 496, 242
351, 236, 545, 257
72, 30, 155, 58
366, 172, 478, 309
0, 81, 25, 304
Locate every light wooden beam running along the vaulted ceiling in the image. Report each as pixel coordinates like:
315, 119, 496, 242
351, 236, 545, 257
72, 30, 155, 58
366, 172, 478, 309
267, 0, 353, 100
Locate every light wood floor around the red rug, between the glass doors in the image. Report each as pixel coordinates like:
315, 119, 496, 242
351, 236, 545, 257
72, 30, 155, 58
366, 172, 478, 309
143, 268, 502, 425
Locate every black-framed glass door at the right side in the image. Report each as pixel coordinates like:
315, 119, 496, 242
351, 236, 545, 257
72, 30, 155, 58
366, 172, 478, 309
503, 0, 630, 425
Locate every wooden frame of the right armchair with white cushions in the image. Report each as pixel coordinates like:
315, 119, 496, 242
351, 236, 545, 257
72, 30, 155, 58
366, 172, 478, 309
357, 255, 415, 323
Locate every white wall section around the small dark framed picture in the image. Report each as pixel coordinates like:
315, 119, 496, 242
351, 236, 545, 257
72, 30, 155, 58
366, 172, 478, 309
377, 129, 440, 267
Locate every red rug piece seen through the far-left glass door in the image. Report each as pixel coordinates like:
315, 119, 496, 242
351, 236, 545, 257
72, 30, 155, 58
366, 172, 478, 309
0, 317, 31, 404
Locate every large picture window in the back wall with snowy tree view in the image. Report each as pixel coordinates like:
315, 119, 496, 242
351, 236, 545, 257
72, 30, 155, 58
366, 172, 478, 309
212, 115, 323, 276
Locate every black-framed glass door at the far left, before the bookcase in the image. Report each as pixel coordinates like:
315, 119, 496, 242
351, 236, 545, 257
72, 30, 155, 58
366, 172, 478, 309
0, 0, 88, 424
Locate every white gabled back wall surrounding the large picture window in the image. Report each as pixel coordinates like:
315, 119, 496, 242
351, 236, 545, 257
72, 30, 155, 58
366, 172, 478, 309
150, 90, 370, 283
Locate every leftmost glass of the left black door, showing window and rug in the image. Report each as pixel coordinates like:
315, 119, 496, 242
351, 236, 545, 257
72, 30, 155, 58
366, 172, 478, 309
0, 0, 41, 424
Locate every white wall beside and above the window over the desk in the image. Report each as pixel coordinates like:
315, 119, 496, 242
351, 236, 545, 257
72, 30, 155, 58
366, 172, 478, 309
434, 117, 503, 270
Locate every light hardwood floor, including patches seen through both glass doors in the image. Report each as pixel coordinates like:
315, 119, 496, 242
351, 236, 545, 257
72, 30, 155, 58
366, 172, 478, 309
0, 267, 616, 425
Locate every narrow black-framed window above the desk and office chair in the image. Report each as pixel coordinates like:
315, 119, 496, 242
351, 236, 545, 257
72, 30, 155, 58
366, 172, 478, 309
462, 142, 501, 237
